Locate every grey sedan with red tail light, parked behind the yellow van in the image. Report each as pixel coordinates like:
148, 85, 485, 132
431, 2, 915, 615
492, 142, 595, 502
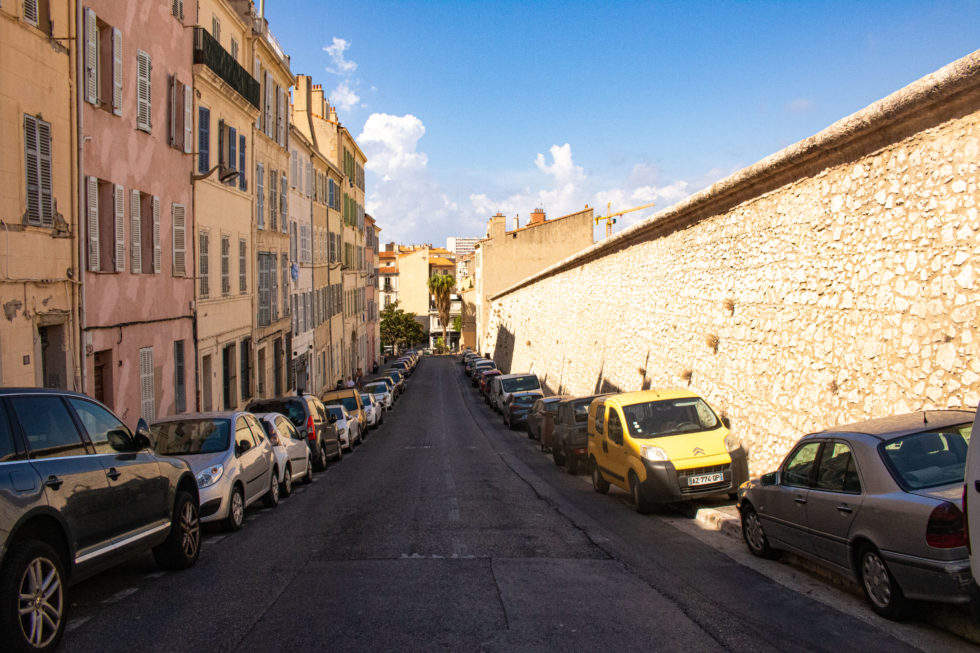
738, 410, 975, 619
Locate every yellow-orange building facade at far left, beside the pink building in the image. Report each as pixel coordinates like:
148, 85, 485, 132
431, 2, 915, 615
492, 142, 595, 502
0, 0, 82, 390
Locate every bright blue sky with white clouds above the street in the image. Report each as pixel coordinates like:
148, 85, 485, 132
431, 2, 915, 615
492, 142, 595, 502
265, 0, 980, 245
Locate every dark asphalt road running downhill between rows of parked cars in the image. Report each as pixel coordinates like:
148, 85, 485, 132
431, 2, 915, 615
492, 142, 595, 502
62, 357, 972, 652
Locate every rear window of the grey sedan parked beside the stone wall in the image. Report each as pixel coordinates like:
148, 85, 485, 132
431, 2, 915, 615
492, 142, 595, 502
881, 422, 973, 490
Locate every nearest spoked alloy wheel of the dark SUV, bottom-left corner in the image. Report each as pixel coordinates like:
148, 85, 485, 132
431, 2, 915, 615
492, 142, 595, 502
0, 540, 68, 651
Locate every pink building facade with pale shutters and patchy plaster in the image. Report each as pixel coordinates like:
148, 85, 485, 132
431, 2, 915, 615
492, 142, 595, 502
79, 0, 197, 426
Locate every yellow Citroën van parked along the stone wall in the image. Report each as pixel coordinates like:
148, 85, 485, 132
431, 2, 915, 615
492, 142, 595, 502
588, 390, 749, 513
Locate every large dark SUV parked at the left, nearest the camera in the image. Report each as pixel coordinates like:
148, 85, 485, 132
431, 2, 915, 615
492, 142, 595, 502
0, 388, 201, 651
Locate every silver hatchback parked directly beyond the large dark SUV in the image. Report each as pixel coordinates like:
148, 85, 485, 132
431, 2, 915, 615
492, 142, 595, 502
150, 410, 279, 531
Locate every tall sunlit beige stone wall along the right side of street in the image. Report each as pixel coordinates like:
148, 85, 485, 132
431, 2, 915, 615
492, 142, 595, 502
484, 52, 980, 473
